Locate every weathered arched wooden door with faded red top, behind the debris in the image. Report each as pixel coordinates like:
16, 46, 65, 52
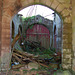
26, 24, 50, 48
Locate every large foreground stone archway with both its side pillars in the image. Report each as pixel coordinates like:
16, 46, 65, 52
1, 0, 72, 69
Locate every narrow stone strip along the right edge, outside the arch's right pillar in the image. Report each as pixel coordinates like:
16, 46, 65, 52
72, 0, 75, 71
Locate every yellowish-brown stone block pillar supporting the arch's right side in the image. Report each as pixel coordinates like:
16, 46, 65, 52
62, 23, 72, 69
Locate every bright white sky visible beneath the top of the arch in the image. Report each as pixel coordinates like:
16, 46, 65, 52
18, 5, 54, 20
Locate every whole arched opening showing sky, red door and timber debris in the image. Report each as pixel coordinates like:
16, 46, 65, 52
11, 5, 62, 72
